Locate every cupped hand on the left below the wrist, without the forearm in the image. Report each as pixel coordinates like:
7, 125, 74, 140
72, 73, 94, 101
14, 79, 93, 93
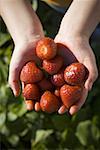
8, 36, 42, 96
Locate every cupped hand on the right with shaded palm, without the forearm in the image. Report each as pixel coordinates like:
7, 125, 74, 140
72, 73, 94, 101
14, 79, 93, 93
55, 34, 98, 115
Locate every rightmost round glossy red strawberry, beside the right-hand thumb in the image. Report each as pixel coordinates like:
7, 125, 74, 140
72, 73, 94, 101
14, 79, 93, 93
64, 63, 86, 85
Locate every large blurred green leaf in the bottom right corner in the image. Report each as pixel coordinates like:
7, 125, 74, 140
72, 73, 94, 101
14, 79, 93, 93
76, 120, 100, 146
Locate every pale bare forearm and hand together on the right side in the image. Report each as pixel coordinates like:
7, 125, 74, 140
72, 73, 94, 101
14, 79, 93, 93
55, 0, 100, 115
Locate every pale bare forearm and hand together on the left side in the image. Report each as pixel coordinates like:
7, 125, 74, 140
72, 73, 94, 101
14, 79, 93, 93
0, 0, 44, 96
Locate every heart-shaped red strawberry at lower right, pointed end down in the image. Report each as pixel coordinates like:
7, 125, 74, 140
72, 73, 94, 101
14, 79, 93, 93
60, 84, 83, 108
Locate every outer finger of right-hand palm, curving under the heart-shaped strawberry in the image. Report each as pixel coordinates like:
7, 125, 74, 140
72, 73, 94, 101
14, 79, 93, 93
69, 88, 88, 115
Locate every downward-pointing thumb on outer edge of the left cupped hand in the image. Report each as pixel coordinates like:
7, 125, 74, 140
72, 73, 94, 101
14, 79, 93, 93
8, 49, 25, 96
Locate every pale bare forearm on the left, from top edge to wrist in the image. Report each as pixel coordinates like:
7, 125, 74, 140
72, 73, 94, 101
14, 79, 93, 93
0, 0, 43, 45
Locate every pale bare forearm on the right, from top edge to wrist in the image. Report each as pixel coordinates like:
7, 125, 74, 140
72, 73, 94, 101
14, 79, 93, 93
59, 0, 100, 39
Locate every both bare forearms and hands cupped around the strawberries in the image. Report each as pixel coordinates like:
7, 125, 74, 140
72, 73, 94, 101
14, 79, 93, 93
0, 0, 100, 115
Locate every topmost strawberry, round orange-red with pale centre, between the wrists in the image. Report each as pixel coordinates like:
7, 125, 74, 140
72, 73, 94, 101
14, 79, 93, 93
36, 37, 57, 59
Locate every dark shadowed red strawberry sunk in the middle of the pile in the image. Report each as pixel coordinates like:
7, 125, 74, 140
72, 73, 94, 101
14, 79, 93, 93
38, 78, 53, 91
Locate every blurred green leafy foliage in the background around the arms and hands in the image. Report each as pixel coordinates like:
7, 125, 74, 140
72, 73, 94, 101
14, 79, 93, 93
0, 2, 100, 150
